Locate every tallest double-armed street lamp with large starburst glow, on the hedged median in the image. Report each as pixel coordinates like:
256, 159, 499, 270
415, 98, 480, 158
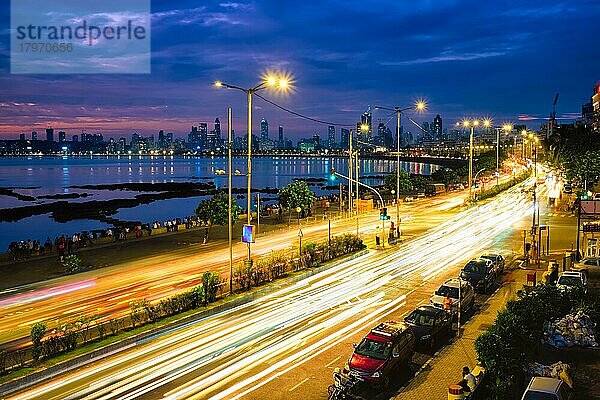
215, 75, 290, 264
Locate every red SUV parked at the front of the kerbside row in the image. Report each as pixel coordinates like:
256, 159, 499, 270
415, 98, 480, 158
346, 321, 415, 388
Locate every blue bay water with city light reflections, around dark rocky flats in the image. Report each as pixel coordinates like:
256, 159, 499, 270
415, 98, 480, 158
0, 156, 439, 251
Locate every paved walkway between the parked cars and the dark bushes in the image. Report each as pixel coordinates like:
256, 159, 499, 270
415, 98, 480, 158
393, 268, 527, 400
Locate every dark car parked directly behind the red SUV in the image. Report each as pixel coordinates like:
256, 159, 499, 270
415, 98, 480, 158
404, 305, 452, 348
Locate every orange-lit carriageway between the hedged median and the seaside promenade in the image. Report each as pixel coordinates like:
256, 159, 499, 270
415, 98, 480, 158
0, 189, 465, 348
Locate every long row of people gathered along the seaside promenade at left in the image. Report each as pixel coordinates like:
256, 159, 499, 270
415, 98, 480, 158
8, 216, 201, 262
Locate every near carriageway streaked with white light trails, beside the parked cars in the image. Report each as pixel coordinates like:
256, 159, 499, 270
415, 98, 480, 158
8, 180, 532, 400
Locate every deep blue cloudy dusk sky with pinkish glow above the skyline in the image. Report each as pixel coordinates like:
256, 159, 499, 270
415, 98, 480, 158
0, 0, 600, 139
